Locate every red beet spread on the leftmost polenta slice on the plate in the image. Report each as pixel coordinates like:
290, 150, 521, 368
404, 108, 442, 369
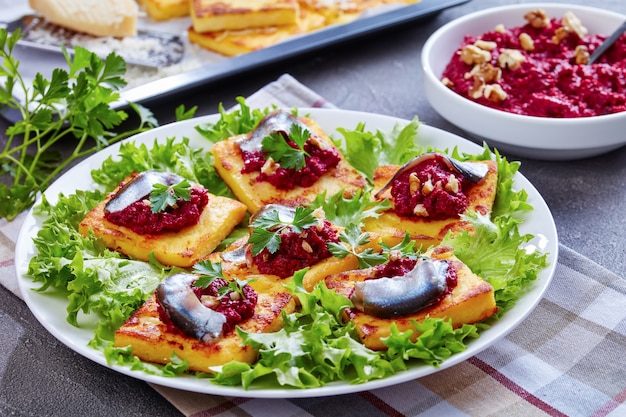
104, 187, 209, 235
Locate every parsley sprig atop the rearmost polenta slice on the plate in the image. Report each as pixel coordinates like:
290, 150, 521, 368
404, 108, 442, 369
261, 123, 311, 169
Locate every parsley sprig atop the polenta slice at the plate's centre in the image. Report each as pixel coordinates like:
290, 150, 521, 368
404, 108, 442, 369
248, 206, 319, 256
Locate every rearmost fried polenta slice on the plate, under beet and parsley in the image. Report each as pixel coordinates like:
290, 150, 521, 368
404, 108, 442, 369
211, 117, 365, 213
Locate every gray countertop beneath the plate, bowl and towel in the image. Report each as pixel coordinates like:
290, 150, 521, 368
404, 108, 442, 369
0, 0, 626, 416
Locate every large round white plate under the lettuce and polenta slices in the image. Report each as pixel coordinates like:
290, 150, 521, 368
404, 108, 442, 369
15, 109, 558, 398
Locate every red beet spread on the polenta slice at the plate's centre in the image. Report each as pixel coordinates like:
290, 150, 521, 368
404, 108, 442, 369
253, 220, 339, 278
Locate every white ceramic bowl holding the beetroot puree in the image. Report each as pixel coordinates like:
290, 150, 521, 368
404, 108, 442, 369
422, 3, 626, 160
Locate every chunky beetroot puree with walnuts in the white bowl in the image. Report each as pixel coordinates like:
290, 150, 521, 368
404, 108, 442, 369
443, 16, 626, 118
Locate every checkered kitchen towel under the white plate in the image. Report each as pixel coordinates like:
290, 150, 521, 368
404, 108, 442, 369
0, 75, 626, 417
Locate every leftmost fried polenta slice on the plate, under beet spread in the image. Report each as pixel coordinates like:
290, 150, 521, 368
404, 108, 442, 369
78, 172, 246, 268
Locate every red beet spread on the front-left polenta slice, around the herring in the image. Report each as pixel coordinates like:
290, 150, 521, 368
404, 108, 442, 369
158, 278, 258, 335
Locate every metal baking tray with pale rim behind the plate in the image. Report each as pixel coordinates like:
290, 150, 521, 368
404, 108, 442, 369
0, 0, 470, 121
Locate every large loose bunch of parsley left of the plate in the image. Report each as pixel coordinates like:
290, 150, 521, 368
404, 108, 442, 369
0, 29, 157, 220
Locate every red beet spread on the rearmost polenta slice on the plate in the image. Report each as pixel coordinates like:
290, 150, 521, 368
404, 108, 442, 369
241, 133, 340, 190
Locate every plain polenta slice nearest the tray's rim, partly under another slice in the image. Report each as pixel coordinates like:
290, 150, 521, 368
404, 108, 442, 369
187, 4, 325, 56
